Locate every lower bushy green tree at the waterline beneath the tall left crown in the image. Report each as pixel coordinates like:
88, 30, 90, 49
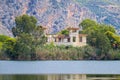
14, 33, 35, 60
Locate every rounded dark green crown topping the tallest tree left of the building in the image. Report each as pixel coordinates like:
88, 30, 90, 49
12, 15, 37, 36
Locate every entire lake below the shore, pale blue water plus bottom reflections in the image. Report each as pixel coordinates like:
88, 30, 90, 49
0, 61, 120, 80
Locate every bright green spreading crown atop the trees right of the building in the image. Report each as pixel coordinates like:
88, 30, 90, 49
79, 19, 115, 33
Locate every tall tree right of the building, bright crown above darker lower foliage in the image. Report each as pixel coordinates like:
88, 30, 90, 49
80, 19, 115, 58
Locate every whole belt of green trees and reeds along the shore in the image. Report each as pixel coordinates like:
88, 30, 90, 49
0, 15, 120, 60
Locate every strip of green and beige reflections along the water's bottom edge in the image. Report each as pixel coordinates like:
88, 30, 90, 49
0, 74, 120, 80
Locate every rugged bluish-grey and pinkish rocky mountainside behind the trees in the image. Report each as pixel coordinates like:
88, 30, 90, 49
0, 0, 120, 33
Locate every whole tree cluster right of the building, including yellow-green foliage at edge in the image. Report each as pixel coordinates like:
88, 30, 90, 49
80, 19, 120, 58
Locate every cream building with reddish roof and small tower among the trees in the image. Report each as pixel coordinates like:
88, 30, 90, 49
46, 27, 87, 47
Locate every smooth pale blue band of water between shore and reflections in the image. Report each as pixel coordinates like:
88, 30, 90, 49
0, 61, 120, 74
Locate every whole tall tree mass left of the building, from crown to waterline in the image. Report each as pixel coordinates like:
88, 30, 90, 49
12, 15, 46, 60
